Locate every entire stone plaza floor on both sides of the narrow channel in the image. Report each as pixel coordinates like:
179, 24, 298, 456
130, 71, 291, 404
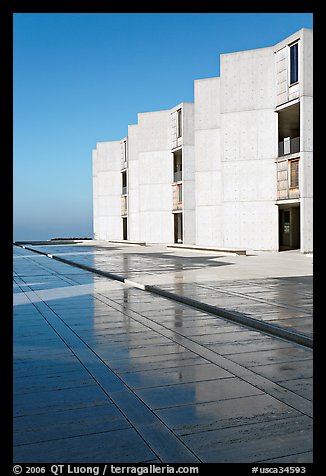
14, 243, 312, 463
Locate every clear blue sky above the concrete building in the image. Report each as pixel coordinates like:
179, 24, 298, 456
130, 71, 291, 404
13, 13, 313, 240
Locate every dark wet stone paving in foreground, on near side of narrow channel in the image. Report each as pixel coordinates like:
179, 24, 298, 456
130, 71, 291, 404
14, 246, 312, 463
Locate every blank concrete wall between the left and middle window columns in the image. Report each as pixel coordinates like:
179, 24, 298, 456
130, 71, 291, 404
129, 110, 173, 243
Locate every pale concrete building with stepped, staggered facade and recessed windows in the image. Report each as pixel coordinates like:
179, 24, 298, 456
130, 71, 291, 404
93, 29, 313, 252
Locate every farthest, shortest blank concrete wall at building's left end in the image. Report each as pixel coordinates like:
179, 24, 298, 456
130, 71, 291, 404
93, 141, 122, 240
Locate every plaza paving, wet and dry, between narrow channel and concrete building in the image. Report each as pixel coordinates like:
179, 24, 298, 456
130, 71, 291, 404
21, 242, 313, 337
